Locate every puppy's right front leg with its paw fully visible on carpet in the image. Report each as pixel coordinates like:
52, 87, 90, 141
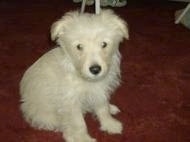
95, 102, 123, 134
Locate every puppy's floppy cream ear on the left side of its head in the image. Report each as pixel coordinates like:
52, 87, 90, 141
50, 11, 79, 41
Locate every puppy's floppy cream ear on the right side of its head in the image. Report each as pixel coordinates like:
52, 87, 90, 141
101, 10, 129, 39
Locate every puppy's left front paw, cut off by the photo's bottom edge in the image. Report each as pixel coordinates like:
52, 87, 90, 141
65, 135, 96, 142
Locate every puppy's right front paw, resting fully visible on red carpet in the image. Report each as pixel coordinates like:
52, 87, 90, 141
100, 118, 123, 134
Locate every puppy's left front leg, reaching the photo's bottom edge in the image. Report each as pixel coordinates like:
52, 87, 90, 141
61, 106, 96, 142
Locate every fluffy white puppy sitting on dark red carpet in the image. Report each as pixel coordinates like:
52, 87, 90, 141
20, 10, 128, 142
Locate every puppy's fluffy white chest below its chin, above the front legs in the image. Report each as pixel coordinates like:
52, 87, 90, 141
58, 63, 119, 112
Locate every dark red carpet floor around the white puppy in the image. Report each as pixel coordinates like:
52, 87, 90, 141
0, 0, 190, 142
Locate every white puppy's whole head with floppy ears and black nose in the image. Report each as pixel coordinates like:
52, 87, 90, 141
51, 10, 128, 80
